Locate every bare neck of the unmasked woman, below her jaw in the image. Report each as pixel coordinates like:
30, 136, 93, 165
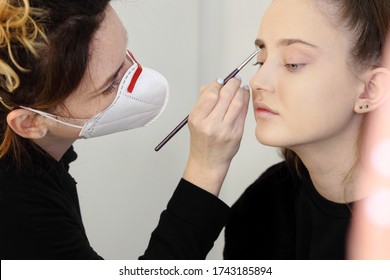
291, 118, 368, 203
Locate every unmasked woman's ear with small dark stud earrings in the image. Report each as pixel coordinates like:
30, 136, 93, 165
354, 67, 390, 114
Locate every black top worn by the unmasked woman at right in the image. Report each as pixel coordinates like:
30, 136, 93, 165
224, 162, 352, 260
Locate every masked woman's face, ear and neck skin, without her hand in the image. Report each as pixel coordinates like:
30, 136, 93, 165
7, 5, 133, 160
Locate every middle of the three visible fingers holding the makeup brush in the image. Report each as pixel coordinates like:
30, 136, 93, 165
209, 78, 241, 121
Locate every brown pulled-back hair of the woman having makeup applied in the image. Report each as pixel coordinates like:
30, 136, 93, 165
282, 0, 390, 180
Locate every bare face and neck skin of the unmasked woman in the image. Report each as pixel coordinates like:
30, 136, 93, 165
251, 0, 386, 203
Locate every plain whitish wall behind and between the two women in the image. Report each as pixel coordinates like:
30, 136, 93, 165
71, 0, 280, 259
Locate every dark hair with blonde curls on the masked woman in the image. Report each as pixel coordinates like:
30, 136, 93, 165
0, 0, 110, 165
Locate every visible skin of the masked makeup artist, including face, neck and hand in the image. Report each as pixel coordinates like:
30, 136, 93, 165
7, 1, 249, 195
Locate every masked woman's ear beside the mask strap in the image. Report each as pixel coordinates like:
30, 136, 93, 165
7, 109, 47, 139
